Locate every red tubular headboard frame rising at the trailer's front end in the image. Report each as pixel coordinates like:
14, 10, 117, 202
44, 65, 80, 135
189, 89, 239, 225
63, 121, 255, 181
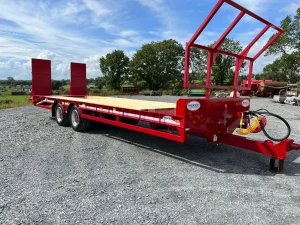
184, 0, 283, 98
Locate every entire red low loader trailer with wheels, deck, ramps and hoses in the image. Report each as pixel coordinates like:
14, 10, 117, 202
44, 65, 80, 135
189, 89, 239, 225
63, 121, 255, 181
30, 0, 300, 171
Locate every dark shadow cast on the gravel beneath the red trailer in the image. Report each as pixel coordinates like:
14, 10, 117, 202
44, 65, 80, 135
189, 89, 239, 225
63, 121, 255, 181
86, 123, 300, 176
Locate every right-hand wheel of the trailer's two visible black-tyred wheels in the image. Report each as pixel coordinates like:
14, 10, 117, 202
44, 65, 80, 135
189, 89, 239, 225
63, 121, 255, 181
69, 106, 92, 132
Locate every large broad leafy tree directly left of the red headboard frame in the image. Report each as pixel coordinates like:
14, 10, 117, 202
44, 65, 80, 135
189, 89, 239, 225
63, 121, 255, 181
130, 39, 184, 90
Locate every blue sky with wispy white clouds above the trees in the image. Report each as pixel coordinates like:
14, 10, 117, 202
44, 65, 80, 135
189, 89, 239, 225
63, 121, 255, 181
0, 0, 300, 80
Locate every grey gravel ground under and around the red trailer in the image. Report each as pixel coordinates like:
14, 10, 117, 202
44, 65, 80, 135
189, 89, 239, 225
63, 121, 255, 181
0, 96, 300, 225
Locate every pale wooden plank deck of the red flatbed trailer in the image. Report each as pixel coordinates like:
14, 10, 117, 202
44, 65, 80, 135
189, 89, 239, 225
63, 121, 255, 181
45, 95, 176, 110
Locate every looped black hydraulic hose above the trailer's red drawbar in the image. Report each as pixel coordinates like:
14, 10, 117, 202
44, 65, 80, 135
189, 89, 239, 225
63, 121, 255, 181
245, 109, 291, 141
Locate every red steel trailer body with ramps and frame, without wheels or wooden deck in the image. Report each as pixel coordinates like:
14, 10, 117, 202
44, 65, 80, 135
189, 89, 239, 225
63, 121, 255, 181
30, 0, 300, 171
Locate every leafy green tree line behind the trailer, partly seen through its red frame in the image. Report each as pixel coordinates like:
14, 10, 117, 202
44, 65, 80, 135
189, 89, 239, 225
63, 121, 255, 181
97, 39, 245, 90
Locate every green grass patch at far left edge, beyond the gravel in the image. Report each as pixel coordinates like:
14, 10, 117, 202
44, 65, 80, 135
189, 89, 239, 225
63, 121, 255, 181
0, 95, 32, 109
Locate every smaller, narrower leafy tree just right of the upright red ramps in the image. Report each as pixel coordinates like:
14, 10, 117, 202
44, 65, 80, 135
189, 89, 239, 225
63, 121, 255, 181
100, 50, 129, 90
